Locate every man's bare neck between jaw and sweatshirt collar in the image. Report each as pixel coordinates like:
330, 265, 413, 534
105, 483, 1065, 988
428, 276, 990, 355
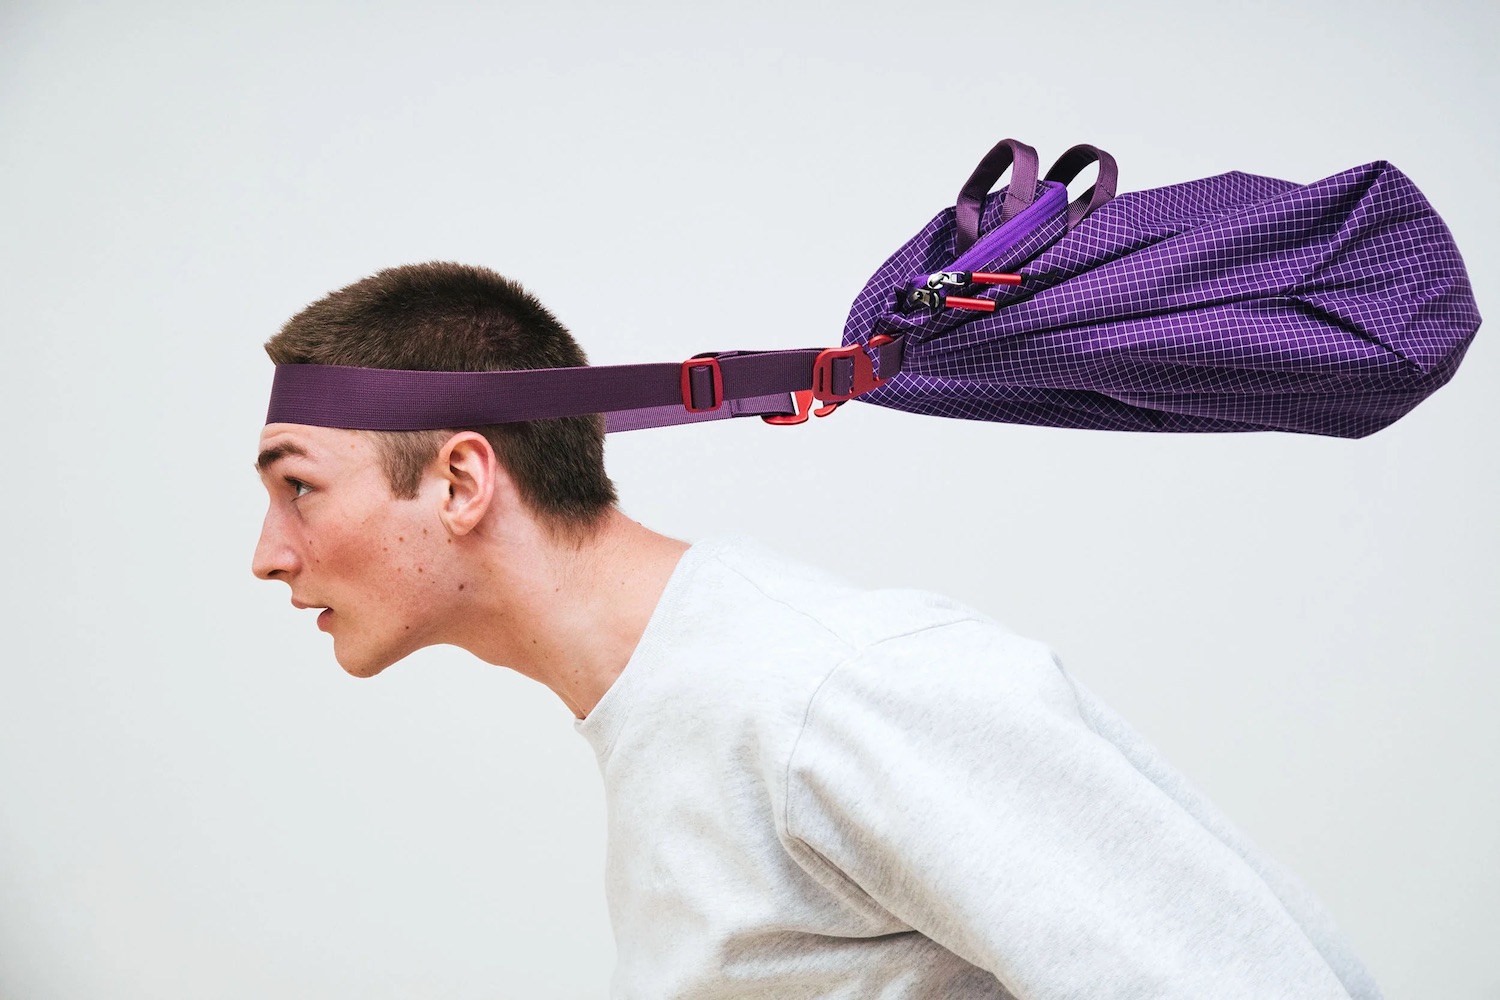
455, 510, 689, 718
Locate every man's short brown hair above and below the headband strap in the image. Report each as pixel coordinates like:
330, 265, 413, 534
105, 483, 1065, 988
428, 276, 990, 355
266, 262, 617, 529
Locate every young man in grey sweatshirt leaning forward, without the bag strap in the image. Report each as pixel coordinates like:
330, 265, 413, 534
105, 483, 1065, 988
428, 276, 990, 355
254, 264, 1379, 1000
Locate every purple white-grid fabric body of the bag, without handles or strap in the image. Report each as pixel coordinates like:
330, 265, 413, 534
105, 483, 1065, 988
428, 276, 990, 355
843, 160, 1479, 438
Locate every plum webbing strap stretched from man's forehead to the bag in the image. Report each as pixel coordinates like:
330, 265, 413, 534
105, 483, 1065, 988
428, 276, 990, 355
266, 339, 903, 430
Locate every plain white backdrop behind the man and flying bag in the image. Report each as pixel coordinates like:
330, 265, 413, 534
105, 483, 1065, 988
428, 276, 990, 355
0, 0, 1500, 1000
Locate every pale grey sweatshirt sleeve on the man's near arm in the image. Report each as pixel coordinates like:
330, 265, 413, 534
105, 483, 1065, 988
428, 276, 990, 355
785, 621, 1379, 1000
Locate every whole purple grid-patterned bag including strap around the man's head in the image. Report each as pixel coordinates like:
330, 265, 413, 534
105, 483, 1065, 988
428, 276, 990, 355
267, 139, 1479, 438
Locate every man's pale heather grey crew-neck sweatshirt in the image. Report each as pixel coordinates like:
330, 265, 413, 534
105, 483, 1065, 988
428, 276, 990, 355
576, 538, 1380, 1000
